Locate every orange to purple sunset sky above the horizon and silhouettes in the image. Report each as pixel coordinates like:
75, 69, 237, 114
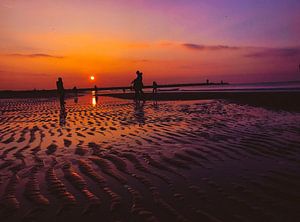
0, 0, 300, 90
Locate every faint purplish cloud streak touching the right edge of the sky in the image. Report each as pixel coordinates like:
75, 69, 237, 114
245, 47, 300, 58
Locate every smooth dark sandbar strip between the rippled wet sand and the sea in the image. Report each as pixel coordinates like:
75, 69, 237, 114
100, 90, 300, 112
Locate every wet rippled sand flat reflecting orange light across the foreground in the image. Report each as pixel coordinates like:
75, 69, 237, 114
0, 95, 300, 222
